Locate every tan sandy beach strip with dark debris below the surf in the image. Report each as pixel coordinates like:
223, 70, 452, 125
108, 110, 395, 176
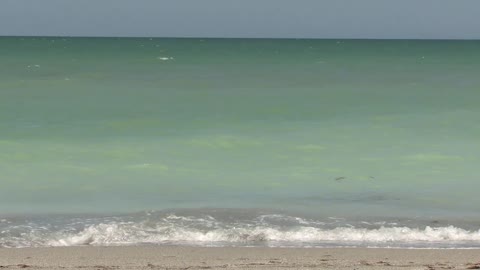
0, 246, 480, 270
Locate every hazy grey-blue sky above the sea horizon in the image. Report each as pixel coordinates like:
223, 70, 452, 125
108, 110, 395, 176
0, 0, 480, 39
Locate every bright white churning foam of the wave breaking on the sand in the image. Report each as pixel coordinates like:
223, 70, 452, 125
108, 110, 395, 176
47, 223, 480, 246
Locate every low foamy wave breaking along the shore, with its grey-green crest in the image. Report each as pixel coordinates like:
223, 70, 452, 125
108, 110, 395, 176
0, 214, 480, 248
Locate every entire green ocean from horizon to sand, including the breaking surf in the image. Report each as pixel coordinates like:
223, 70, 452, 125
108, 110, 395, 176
0, 37, 480, 248
